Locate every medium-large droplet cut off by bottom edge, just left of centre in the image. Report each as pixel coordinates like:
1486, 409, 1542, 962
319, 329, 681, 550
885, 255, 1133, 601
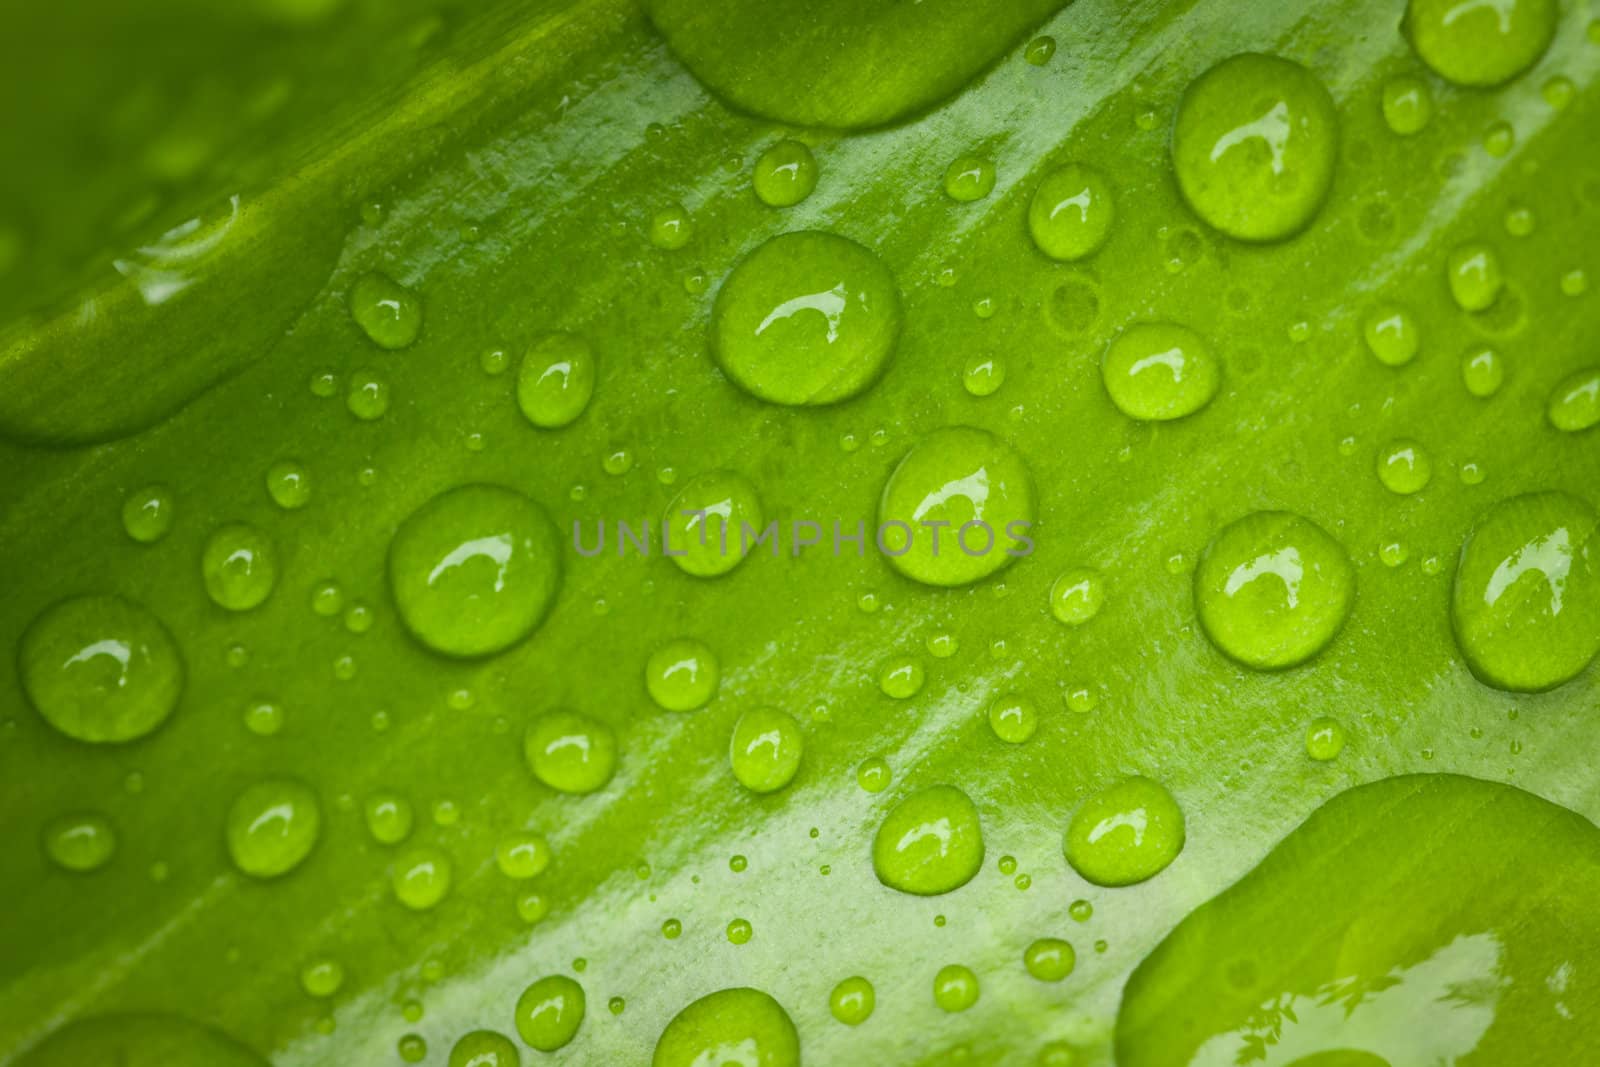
650, 987, 800, 1067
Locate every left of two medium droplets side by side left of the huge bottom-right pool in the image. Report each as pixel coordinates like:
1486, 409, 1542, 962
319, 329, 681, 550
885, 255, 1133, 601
872, 785, 984, 896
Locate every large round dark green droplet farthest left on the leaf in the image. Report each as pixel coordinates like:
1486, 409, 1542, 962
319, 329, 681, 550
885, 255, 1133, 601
18, 597, 184, 744
